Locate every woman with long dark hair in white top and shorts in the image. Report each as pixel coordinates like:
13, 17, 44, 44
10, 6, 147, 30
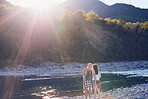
93, 64, 101, 99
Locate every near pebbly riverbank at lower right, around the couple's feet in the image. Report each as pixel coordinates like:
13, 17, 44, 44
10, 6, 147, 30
63, 83, 148, 99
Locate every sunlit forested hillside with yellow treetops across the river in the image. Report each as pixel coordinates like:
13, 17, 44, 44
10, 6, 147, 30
0, 2, 148, 62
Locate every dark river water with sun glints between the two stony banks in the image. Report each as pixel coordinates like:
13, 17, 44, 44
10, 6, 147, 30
0, 74, 148, 99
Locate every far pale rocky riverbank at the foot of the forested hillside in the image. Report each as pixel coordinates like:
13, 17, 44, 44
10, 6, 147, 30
0, 61, 148, 76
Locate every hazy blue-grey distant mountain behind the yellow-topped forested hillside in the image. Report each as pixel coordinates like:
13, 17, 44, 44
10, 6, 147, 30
61, 0, 148, 22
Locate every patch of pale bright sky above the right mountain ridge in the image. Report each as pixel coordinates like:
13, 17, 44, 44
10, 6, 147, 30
100, 0, 148, 8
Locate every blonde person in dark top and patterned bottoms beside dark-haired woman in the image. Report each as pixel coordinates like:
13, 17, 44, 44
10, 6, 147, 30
82, 63, 95, 99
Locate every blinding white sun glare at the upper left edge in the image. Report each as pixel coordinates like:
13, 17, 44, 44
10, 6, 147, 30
7, 0, 64, 9
